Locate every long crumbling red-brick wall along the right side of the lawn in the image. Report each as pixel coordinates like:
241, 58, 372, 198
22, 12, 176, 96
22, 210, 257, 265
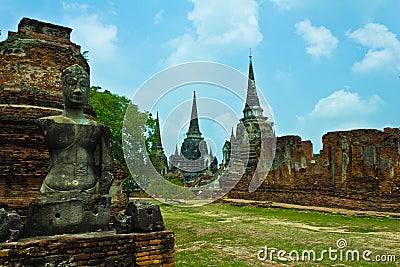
228, 128, 400, 212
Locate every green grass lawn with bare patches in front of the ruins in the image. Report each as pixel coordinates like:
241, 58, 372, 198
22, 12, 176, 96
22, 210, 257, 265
161, 204, 400, 266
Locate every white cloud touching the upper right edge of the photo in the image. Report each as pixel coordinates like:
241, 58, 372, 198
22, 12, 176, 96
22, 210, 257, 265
346, 23, 400, 73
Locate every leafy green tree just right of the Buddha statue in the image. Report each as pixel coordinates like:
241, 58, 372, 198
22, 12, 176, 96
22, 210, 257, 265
90, 86, 161, 195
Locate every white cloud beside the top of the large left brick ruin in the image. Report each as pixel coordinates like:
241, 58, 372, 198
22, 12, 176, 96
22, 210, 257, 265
67, 14, 118, 62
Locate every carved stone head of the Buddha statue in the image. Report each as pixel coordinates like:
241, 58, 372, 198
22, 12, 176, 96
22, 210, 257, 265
61, 64, 90, 109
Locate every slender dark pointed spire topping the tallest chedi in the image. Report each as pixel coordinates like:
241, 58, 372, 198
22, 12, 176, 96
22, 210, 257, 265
243, 54, 263, 118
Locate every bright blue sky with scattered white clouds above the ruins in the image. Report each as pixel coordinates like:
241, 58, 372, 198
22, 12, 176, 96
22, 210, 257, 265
0, 0, 400, 159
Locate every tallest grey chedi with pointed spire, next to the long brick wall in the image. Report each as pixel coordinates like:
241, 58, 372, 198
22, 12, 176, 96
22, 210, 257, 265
220, 56, 275, 191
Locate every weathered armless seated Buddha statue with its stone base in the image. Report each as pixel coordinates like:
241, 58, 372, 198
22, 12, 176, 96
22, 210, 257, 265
26, 64, 114, 236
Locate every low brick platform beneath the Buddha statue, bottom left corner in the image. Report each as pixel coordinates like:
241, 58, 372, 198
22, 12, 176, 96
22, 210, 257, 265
0, 230, 175, 267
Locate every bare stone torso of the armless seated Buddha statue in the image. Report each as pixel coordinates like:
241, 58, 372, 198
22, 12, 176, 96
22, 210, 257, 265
39, 116, 102, 193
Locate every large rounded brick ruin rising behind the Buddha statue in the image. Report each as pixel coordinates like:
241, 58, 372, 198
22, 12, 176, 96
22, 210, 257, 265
0, 18, 124, 219
